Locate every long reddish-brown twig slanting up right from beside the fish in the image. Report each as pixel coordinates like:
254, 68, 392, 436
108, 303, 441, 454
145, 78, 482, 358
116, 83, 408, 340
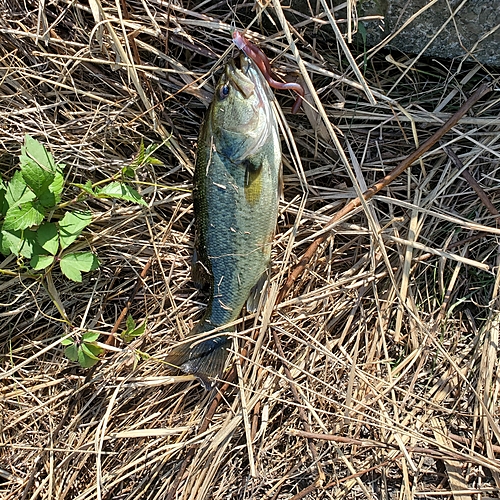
277, 84, 491, 303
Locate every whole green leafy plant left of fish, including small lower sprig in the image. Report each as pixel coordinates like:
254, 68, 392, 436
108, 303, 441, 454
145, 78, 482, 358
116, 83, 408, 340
0, 135, 160, 368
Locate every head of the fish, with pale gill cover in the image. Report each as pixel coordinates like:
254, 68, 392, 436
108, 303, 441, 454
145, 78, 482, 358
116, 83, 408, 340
209, 54, 275, 162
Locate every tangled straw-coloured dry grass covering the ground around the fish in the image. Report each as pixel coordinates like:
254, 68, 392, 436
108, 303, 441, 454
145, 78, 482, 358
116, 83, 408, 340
0, 0, 500, 500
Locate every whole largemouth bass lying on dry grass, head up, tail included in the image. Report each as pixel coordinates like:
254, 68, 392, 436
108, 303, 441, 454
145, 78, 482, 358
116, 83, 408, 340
166, 50, 281, 390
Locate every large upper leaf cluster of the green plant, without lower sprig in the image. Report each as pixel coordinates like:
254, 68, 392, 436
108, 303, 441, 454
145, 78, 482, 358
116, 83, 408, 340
0, 135, 148, 282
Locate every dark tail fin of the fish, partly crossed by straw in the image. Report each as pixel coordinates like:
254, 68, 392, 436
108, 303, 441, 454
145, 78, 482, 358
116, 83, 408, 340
165, 335, 231, 391
